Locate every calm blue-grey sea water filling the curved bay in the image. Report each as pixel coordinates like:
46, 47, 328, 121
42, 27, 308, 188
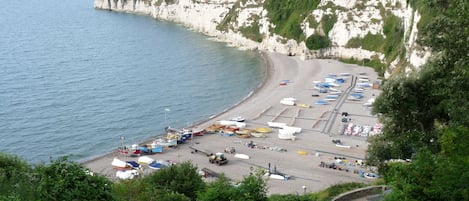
0, 0, 265, 163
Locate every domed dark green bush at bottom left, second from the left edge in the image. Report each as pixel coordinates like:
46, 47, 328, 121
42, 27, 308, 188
35, 157, 114, 200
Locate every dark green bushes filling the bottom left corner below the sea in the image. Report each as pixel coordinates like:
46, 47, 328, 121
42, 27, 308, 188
0, 154, 113, 200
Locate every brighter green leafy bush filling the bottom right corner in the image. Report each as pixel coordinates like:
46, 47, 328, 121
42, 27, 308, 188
385, 127, 469, 200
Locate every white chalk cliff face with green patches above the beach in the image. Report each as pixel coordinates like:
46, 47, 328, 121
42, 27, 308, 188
94, 0, 430, 75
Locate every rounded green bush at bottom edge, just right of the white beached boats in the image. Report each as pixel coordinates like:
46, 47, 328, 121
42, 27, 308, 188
144, 162, 205, 200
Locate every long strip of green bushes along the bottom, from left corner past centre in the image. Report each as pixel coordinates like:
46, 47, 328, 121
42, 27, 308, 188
0, 153, 372, 201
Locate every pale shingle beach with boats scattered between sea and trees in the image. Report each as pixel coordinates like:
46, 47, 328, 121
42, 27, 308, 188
83, 52, 380, 194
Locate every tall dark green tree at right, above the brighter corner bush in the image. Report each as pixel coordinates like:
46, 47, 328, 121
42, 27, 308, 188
367, 0, 469, 165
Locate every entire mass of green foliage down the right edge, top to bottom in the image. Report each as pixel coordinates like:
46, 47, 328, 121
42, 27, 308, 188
367, 0, 469, 200
